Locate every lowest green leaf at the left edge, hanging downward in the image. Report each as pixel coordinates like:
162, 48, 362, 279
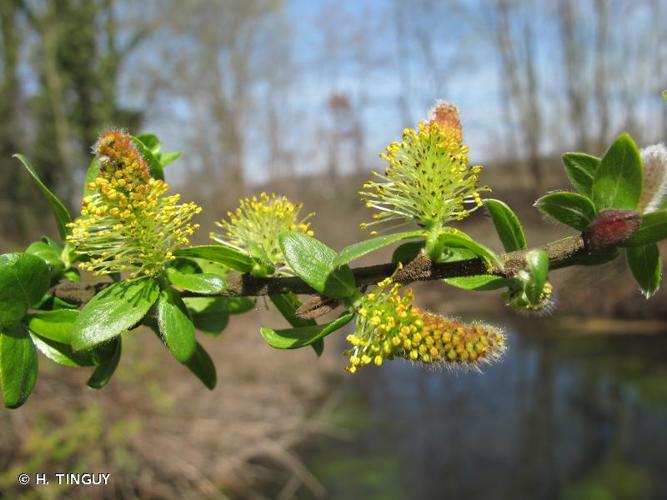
0, 323, 38, 408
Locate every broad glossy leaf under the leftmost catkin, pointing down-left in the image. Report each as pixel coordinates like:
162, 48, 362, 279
72, 278, 160, 351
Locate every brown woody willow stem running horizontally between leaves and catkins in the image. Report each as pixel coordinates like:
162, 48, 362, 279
51, 236, 596, 304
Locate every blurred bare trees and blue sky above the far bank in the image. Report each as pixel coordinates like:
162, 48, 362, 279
0, 0, 667, 241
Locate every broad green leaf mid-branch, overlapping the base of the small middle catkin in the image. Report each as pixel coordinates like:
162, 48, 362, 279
280, 231, 357, 297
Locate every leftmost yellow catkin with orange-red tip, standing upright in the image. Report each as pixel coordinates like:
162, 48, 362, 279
67, 130, 201, 277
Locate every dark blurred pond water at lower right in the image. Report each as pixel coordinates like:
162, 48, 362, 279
296, 320, 667, 500
